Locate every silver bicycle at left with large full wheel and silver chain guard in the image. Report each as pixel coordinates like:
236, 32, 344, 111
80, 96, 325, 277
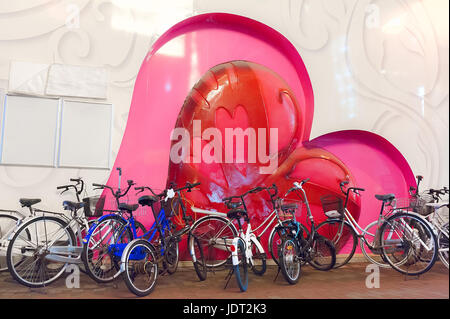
6, 179, 95, 288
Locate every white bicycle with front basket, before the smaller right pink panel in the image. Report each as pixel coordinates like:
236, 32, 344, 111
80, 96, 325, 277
317, 181, 437, 275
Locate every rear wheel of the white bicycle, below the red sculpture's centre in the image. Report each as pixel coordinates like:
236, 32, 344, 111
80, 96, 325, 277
189, 216, 238, 268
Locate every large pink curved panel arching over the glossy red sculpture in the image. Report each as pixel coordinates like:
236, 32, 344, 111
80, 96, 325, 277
103, 13, 313, 225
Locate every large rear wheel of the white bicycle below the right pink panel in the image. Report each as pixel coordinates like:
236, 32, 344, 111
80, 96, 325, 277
380, 213, 438, 276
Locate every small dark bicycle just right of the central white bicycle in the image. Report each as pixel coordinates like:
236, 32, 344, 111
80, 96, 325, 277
278, 178, 336, 285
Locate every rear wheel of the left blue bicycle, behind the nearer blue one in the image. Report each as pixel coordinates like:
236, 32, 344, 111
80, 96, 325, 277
82, 215, 133, 283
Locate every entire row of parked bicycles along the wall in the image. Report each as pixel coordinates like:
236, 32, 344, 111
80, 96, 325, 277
0, 168, 449, 296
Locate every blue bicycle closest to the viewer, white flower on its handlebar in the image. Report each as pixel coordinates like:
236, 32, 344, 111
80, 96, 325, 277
121, 182, 207, 297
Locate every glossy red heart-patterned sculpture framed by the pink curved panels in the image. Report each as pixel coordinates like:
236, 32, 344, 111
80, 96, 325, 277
167, 61, 360, 258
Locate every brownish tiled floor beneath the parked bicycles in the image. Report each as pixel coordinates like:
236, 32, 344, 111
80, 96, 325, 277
0, 263, 449, 299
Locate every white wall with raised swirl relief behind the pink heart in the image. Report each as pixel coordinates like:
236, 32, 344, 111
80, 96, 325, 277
0, 0, 449, 215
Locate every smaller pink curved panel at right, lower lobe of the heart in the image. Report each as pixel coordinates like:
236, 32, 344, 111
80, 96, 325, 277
305, 130, 416, 251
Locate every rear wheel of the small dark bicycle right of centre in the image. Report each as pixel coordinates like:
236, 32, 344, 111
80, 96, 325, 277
308, 233, 336, 271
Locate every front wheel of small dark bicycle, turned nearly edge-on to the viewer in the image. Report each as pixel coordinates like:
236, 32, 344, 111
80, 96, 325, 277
279, 236, 302, 285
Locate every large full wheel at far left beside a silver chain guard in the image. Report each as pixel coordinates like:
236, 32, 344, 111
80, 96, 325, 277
6, 216, 76, 288
